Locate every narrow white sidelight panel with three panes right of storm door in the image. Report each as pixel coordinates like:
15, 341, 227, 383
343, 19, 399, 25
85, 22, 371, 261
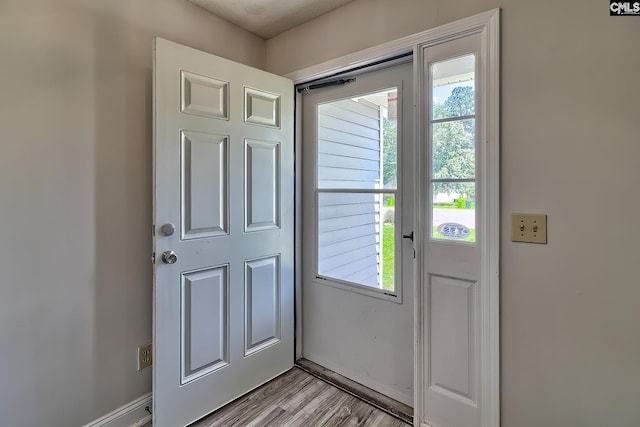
421, 35, 485, 427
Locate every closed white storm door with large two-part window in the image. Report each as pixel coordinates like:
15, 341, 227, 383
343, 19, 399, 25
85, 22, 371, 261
302, 61, 414, 406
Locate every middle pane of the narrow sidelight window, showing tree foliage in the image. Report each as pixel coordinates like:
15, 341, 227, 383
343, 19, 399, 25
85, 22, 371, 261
431, 119, 476, 179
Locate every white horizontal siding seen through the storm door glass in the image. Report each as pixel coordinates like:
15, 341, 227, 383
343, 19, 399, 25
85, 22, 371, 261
317, 99, 382, 287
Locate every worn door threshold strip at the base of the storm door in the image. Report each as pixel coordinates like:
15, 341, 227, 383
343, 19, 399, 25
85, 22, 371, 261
295, 358, 413, 425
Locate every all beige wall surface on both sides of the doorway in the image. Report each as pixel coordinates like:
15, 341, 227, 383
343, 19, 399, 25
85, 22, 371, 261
0, 0, 640, 427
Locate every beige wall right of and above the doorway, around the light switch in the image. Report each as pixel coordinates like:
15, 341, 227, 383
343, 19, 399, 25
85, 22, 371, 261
267, 0, 640, 427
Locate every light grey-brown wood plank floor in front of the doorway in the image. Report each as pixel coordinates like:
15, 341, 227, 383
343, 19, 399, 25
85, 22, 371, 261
190, 368, 409, 427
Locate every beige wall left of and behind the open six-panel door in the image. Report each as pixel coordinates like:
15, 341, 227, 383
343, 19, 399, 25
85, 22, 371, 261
0, 0, 265, 427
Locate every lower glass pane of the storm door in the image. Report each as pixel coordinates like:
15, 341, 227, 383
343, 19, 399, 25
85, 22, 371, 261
318, 192, 395, 291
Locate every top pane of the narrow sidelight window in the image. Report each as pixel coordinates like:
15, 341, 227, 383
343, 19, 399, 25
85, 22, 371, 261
431, 54, 475, 119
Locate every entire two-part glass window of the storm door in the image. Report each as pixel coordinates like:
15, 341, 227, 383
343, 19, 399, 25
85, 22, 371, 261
316, 88, 398, 292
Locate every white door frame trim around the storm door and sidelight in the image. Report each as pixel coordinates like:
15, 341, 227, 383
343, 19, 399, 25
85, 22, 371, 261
285, 9, 500, 427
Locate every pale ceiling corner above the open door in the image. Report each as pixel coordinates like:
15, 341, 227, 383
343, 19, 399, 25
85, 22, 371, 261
189, 0, 353, 39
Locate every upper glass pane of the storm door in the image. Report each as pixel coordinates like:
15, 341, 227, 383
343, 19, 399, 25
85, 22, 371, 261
317, 88, 398, 189
